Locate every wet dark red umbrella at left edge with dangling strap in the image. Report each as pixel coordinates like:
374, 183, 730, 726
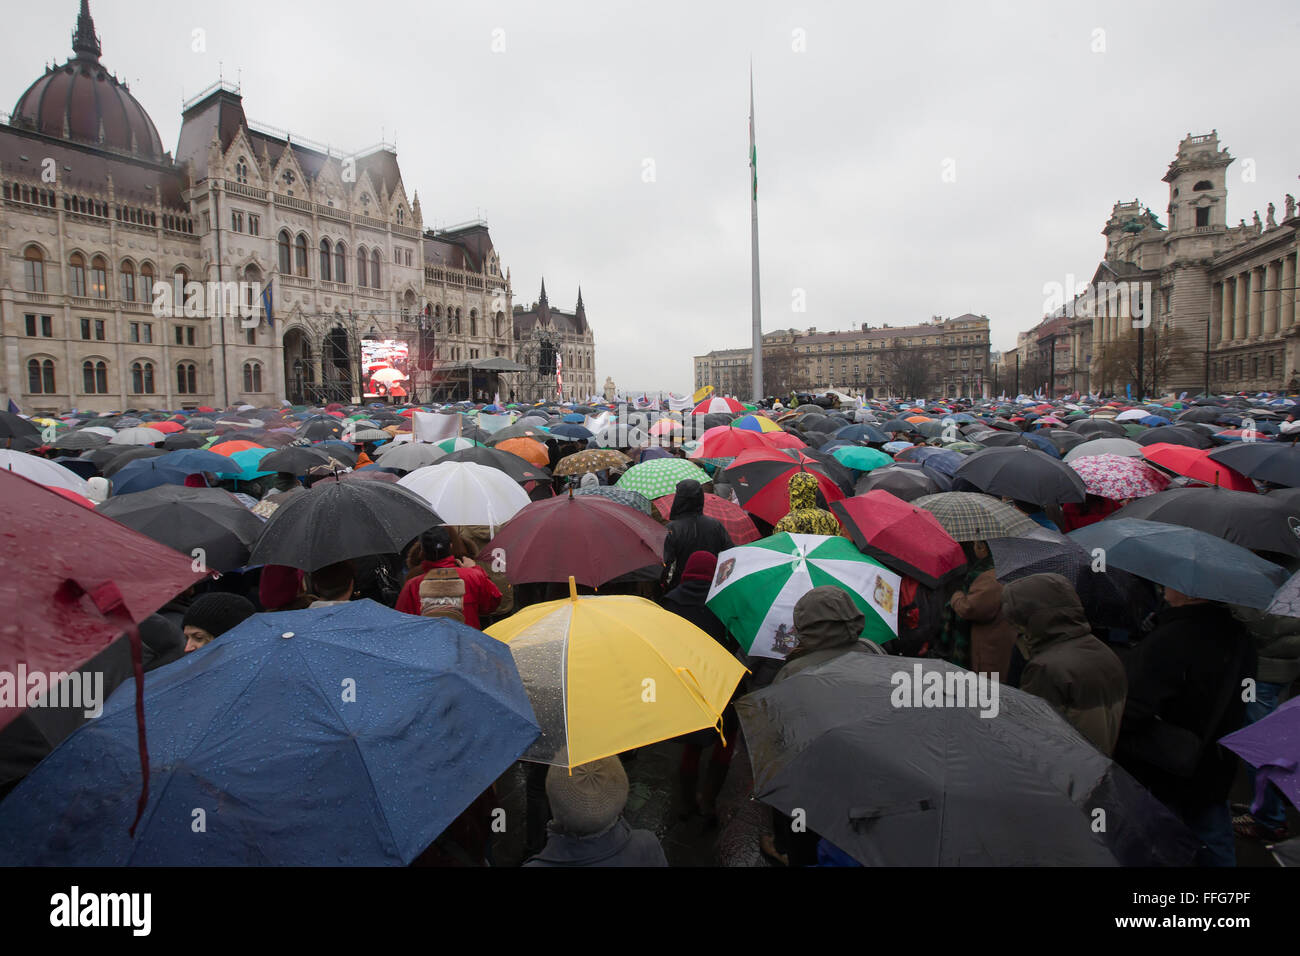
0, 471, 208, 832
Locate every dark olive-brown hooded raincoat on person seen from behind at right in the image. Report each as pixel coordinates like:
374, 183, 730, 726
1002, 574, 1128, 756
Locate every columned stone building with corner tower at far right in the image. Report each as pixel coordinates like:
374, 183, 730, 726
1034, 130, 1300, 394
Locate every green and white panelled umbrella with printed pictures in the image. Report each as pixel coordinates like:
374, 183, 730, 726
706, 533, 902, 659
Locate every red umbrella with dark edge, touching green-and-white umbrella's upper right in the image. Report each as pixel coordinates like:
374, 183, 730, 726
831, 489, 966, 588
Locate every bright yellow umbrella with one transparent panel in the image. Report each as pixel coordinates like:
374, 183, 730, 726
488, 578, 745, 769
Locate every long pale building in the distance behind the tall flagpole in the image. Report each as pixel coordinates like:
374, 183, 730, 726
694, 312, 992, 398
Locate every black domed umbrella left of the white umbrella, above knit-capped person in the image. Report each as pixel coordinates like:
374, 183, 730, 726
251, 477, 443, 571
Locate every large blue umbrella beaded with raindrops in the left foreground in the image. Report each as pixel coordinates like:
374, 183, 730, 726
0, 601, 538, 866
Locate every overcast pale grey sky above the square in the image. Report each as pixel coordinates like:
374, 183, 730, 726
0, 0, 1300, 390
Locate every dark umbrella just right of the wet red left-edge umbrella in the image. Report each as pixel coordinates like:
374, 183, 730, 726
95, 485, 269, 571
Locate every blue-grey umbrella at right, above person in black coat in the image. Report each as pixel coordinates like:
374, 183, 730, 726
1070, 518, 1287, 607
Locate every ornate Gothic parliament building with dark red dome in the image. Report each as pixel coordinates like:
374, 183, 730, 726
0, 0, 597, 414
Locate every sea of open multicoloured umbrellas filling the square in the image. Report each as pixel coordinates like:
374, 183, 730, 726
0, 395, 1300, 864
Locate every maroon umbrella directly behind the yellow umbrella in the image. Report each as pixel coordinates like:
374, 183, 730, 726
480, 494, 668, 588
